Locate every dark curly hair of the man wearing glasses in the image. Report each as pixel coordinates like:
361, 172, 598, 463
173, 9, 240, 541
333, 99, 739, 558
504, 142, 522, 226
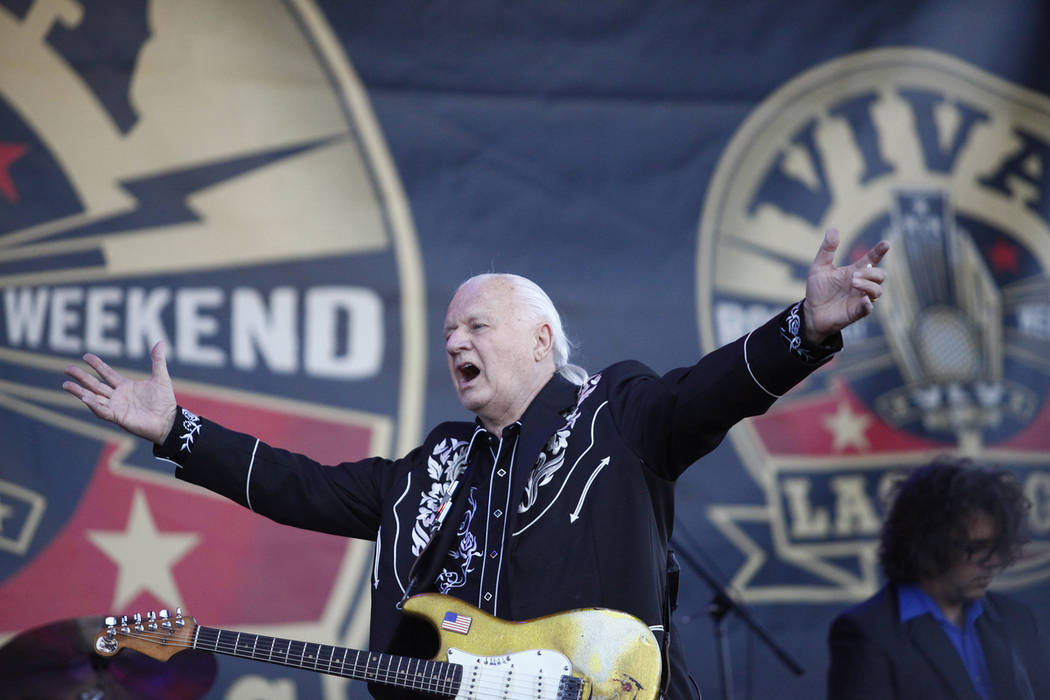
879, 458, 1029, 584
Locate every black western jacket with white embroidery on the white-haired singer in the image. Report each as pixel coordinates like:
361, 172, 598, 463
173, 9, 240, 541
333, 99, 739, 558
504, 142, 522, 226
158, 304, 827, 698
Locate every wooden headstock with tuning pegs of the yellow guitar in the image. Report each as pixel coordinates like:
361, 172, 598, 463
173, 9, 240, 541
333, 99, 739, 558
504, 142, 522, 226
95, 608, 197, 661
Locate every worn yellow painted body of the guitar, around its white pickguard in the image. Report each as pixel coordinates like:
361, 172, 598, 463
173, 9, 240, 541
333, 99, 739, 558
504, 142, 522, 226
404, 593, 660, 700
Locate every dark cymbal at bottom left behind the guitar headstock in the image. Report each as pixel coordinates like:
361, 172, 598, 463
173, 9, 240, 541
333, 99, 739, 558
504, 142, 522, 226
0, 617, 218, 700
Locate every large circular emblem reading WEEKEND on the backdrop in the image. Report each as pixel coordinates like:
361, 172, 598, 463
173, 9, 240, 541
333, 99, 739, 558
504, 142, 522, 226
0, 0, 425, 695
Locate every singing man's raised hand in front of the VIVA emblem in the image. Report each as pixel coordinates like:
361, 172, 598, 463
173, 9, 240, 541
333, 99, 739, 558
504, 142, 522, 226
805, 229, 889, 344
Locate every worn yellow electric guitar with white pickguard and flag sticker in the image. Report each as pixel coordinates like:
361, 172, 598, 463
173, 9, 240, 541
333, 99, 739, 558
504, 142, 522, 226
95, 593, 660, 700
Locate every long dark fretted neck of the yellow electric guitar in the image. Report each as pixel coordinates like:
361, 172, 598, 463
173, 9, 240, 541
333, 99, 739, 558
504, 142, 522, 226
192, 625, 463, 697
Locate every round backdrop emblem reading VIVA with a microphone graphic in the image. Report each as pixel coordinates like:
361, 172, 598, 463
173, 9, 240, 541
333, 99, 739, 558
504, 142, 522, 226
696, 49, 1050, 601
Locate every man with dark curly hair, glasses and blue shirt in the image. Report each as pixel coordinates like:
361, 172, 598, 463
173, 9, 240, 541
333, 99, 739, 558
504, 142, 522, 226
827, 459, 1050, 700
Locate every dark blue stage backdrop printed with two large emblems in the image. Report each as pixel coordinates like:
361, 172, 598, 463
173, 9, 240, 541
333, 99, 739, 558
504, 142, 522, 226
0, 0, 1050, 698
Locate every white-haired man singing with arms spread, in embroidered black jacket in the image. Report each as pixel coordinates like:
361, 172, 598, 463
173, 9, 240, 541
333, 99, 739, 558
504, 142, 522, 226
63, 229, 888, 700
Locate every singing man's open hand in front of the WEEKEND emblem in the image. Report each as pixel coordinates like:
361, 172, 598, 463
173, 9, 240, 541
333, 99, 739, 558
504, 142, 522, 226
62, 341, 175, 444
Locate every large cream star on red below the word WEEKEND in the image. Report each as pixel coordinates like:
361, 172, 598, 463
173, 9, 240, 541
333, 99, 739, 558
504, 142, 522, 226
87, 490, 201, 610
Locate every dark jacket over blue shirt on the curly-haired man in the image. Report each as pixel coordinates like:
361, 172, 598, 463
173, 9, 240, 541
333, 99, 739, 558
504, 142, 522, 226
827, 586, 1050, 700
